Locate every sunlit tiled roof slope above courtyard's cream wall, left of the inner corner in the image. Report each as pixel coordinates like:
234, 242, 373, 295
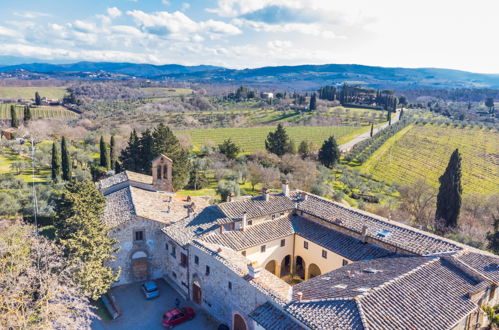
202, 215, 294, 251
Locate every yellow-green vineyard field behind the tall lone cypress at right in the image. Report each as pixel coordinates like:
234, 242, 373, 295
361, 125, 499, 194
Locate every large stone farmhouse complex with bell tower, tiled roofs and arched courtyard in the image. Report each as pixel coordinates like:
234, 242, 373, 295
99, 156, 499, 330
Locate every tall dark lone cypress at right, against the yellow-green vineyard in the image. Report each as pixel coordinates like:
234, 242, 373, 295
435, 149, 463, 234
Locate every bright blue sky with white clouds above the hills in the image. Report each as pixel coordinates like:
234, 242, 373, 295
0, 0, 499, 73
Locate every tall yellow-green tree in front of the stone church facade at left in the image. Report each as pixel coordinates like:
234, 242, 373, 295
54, 180, 119, 300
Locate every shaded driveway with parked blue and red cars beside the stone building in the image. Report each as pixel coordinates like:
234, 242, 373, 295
92, 280, 218, 330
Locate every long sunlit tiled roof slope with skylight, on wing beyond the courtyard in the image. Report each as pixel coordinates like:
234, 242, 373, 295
292, 193, 461, 255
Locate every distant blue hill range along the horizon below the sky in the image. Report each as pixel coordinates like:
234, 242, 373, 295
0, 62, 499, 90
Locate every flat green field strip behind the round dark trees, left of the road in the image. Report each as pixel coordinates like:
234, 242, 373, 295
176, 126, 370, 153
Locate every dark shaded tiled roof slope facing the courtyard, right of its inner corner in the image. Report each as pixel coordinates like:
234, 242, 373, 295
293, 216, 393, 261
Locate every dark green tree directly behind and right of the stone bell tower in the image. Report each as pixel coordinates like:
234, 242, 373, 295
149, 123, 191, 190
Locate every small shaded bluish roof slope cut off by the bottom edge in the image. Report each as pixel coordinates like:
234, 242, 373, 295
249, 302, 304, 330
